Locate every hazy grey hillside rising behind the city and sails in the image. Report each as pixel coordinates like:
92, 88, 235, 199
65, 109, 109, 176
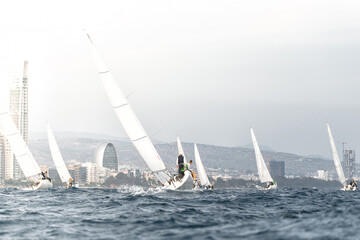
29, 134, 335, 176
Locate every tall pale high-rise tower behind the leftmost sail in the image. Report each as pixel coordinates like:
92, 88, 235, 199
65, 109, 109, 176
0, 61, 29, 179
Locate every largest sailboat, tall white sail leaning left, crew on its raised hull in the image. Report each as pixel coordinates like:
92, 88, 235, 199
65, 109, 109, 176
87, 34, 190, 190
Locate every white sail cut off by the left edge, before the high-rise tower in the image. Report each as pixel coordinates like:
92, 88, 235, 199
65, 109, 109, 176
0, 112, 41, 178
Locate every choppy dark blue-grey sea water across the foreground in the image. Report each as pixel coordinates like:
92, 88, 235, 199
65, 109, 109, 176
0, 187, 360, 239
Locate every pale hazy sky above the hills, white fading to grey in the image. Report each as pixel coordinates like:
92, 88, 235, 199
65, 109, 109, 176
0, 0, 360, 157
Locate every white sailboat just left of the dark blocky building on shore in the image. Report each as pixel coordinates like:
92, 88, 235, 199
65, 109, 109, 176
250, 128, 277, 190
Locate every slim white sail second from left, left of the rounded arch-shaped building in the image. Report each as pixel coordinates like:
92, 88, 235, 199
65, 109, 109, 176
47, 124, 71, 183
